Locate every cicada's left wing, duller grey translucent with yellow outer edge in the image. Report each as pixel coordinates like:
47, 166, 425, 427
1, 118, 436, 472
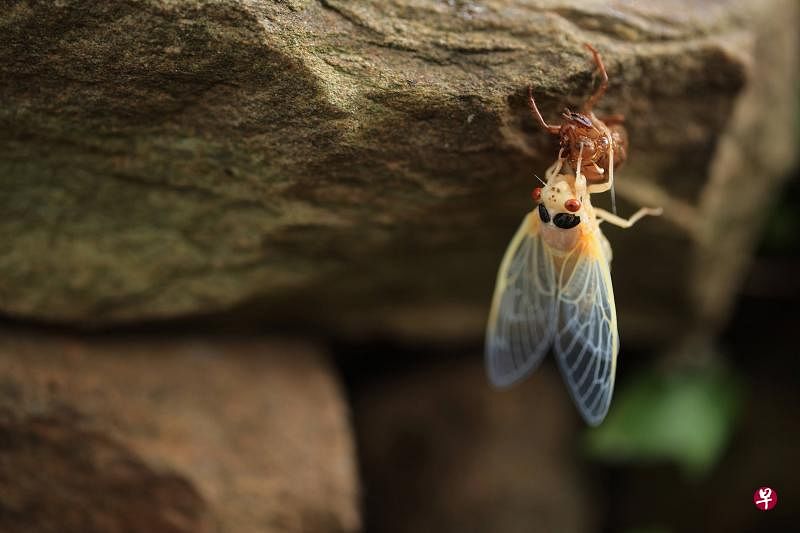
486, 213, 556, 387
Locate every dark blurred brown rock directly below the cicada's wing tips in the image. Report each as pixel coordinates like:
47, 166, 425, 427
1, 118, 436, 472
354, 357, 602, 533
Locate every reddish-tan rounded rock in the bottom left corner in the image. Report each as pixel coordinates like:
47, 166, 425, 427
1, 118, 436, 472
0, 333, 359, 533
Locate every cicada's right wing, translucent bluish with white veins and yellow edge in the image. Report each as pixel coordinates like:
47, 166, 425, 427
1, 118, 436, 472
554, 234, 619, 426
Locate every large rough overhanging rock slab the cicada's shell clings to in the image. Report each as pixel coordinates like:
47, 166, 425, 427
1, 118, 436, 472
0, 0, 797, 342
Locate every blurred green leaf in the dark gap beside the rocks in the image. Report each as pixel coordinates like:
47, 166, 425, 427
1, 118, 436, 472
587, 369, 741, 477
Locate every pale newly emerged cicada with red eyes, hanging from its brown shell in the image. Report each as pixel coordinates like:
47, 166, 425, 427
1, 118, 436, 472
486, 44, 661, 426
